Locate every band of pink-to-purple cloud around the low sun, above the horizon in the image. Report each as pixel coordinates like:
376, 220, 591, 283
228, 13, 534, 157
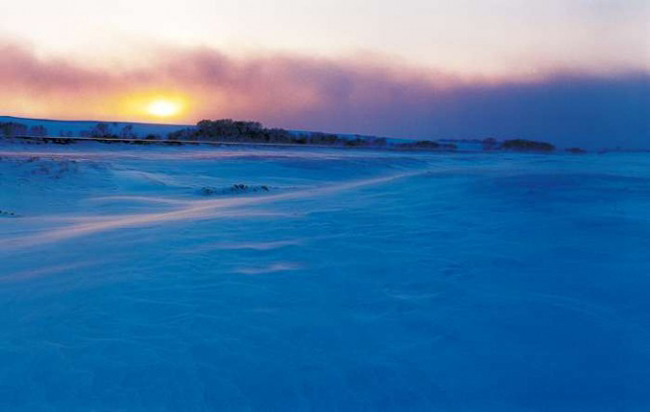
0, 44, 650, 148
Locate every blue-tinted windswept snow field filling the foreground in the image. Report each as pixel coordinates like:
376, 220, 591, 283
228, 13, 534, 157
0, 144, 650, 412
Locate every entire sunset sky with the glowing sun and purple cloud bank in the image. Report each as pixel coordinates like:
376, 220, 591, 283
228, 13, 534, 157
0, 0, 650, 147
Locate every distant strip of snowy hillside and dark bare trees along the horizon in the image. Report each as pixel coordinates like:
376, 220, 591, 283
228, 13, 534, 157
0, 116, 586, 154
